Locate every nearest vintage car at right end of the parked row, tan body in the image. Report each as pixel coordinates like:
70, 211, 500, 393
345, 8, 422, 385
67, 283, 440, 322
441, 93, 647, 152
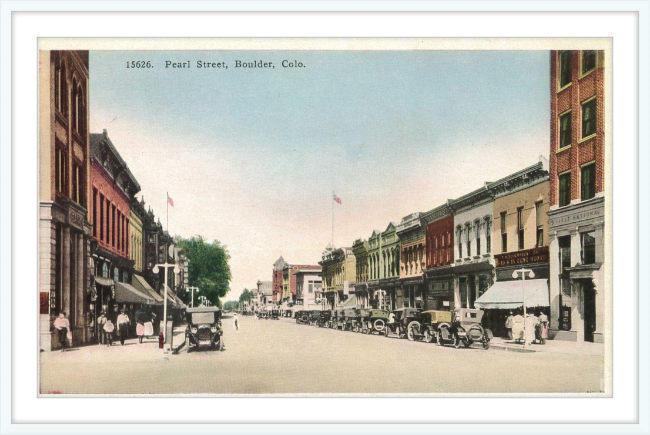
437, 308, 492, 349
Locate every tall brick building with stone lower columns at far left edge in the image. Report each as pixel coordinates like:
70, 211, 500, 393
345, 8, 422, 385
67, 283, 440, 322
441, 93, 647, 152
39, 50, 92, 351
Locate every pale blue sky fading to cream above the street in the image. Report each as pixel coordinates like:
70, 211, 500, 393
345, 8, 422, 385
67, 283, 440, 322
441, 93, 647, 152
90, 51, 550, 299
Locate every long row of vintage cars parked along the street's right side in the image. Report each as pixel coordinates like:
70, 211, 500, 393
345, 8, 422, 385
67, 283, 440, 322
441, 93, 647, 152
296, 308, 493, 349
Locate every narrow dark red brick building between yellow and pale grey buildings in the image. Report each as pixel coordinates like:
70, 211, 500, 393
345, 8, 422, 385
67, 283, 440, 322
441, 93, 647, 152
422, 202, 454, 311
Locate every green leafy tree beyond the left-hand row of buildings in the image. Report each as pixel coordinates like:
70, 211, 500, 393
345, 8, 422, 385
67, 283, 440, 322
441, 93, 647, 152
176, 236, 232, 307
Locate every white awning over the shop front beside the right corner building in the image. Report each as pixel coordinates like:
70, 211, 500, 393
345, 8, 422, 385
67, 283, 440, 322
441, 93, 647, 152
474, 279, 550, 310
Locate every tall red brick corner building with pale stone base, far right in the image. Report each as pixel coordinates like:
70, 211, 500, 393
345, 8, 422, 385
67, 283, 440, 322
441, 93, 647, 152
549, 50, 605, 342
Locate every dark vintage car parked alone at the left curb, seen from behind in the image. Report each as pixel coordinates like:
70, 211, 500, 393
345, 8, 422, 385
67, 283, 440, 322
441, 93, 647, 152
185, 307, 223, 352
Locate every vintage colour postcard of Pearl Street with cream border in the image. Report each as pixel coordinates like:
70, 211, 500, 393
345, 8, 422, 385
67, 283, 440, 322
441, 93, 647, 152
35, 39, 612, 397
